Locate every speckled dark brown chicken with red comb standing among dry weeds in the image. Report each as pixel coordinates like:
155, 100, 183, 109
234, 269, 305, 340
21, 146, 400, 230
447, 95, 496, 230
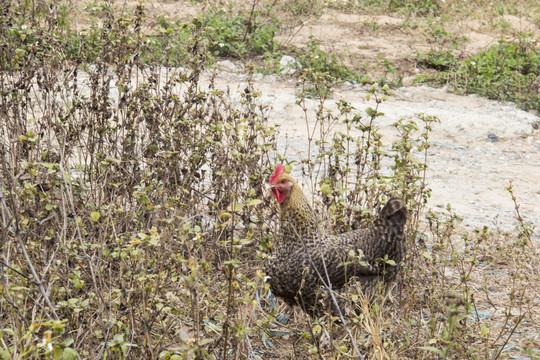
266, 164, 408, 316
